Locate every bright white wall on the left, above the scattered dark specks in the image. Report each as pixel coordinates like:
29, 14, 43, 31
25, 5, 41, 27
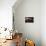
0, 0, 16, 29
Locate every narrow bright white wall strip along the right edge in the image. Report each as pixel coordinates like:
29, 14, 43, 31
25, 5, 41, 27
41, 0, 46, 46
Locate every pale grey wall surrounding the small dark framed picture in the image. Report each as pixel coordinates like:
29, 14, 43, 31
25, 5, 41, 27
13, 0, 41, 46
